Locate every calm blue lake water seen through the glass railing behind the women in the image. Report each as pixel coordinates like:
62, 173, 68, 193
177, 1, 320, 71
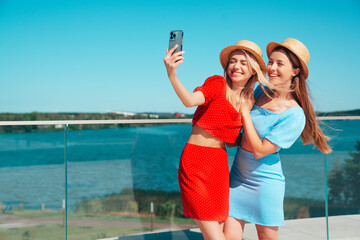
0, 120, 360, 209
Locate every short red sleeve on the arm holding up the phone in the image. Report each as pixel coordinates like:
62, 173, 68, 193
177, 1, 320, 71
193, 75, 226, 105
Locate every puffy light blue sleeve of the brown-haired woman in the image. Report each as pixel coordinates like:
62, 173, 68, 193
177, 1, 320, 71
264, 107, 305, 148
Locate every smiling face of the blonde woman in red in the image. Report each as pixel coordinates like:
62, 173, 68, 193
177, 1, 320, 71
226, 50, 253, 86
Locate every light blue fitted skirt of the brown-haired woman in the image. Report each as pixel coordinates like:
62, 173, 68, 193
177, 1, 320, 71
229, 147, 285, 226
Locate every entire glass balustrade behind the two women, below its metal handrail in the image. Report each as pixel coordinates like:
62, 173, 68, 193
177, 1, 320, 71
0, 120, 360, 240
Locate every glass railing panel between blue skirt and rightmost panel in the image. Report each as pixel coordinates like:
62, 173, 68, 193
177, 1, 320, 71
280, 121, 338, 239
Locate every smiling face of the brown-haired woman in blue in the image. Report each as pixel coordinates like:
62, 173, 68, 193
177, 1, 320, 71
267, 50, 300, 89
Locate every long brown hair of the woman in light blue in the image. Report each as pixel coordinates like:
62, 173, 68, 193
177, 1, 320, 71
273, 46, 332, 153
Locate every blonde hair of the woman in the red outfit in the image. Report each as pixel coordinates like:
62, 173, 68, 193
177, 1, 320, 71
224, 50, 271, 111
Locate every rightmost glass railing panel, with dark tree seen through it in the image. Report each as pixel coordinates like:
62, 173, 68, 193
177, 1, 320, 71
325, 120, 360, 239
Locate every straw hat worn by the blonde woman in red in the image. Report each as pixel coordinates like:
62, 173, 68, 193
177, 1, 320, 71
220, 40, 266, 72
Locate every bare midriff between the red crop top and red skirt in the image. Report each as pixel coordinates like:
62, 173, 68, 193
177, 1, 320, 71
188, 125, 225, 148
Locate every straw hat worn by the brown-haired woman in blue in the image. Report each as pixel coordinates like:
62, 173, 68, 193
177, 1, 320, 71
266, 38, 310, 79
